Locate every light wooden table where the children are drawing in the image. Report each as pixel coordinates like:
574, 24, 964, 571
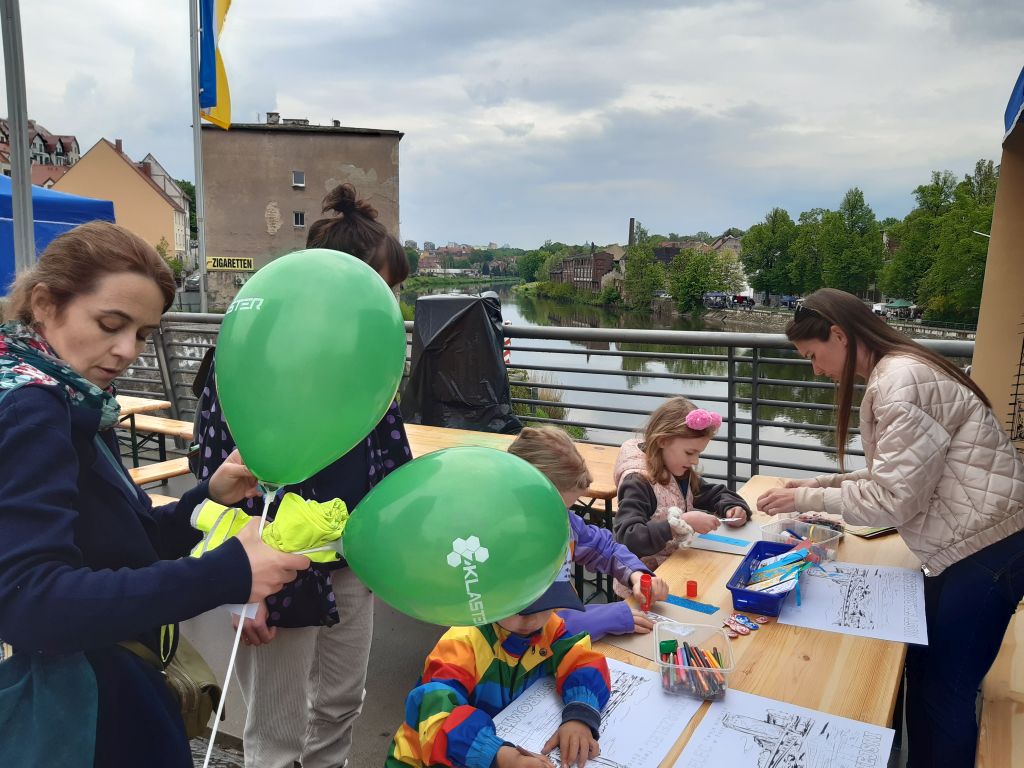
595, 475, 919, 768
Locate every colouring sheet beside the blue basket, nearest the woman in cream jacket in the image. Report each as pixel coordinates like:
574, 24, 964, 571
778, 562, 928, 645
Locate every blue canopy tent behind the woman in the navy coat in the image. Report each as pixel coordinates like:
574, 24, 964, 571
0, 176, 114, 296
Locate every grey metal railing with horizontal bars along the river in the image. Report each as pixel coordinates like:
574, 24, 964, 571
119, 312, 974, 485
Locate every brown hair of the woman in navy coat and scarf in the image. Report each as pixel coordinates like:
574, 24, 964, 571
6, 221, 176, 325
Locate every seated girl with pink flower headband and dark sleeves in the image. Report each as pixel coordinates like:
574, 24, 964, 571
613, 397, 751, 570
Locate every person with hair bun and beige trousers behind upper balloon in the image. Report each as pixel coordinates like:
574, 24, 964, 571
197, 183, 412, 768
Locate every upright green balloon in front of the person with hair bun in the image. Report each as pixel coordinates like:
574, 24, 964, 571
216, 248, 406, 485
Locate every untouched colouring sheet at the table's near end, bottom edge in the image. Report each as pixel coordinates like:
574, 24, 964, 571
675, 689, 894, 768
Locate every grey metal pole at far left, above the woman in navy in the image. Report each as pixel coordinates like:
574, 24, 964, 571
0, 0, 36, 274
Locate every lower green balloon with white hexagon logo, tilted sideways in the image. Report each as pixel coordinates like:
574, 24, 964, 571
343, 446, 569, 626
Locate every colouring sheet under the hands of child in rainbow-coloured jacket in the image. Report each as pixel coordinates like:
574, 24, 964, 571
495, 659, 701, 768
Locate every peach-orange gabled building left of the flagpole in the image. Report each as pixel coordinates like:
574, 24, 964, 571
53, 138, 188, 260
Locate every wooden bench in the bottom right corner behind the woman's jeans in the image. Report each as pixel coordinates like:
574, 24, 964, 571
976, 611, 1024, 768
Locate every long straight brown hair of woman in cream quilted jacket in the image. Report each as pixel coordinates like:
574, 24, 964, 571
785, 288, 991, 470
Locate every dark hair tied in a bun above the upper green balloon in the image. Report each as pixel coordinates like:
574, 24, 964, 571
306, 183, 409, 288
